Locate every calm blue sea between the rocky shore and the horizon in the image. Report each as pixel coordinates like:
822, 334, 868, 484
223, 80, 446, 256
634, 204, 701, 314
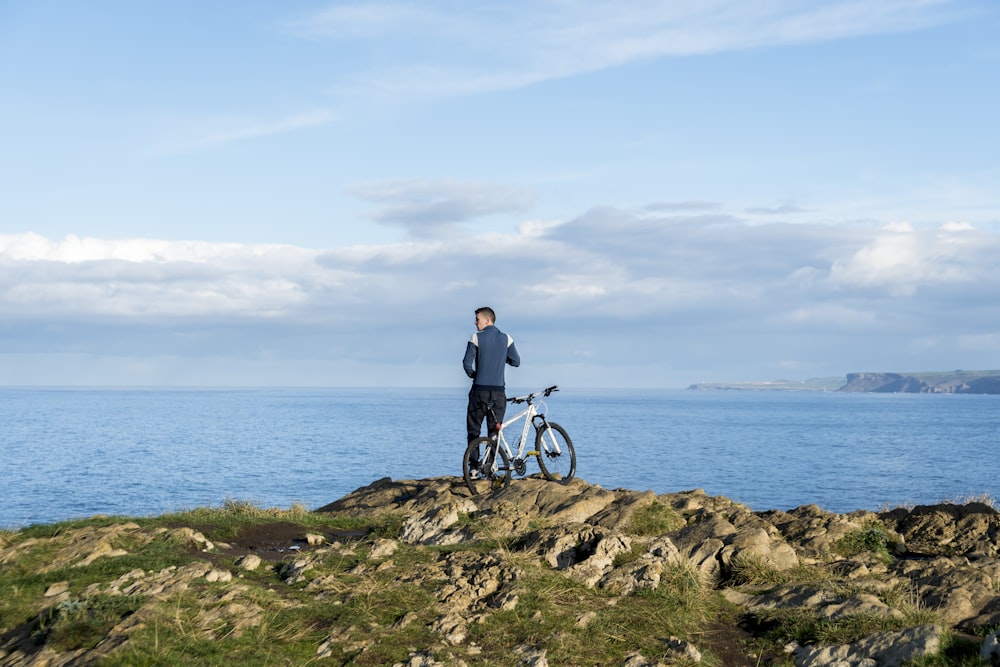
0, 389, 1000, 528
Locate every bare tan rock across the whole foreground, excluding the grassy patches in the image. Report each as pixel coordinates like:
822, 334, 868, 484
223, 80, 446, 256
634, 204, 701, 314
0, 477, 1000, 667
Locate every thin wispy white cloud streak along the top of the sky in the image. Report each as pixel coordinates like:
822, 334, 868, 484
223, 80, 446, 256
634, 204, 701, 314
288, 0, 952, 96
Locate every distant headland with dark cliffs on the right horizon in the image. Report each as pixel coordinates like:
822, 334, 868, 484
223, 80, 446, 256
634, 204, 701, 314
688, 370, 1000, 394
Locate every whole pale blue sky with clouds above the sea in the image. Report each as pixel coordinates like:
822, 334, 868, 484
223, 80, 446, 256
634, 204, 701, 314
0, 0, 1000, 390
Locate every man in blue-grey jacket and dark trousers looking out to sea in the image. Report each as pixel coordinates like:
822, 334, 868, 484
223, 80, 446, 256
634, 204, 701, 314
462, 306, 521, 468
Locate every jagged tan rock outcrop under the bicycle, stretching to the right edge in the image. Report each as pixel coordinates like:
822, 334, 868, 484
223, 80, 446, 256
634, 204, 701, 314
320, 478, 1000, 665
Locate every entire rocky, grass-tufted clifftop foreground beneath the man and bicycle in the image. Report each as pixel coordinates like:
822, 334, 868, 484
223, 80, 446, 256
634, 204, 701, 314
0, 477, 1000, 667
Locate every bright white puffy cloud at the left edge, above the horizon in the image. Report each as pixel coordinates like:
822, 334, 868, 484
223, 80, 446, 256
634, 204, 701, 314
0, 233, 351, 317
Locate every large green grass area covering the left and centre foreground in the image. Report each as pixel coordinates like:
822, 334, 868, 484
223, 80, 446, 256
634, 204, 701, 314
0, 503, 718, 667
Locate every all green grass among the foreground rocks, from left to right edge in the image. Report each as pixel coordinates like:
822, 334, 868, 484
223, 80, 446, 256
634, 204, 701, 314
0, 501, 979, 667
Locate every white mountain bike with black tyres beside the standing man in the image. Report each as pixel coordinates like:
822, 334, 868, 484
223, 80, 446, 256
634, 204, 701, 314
462, 385, 576, 495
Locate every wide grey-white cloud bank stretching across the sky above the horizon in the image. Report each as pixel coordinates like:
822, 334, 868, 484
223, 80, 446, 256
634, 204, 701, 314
0, 204, 1000, 386
